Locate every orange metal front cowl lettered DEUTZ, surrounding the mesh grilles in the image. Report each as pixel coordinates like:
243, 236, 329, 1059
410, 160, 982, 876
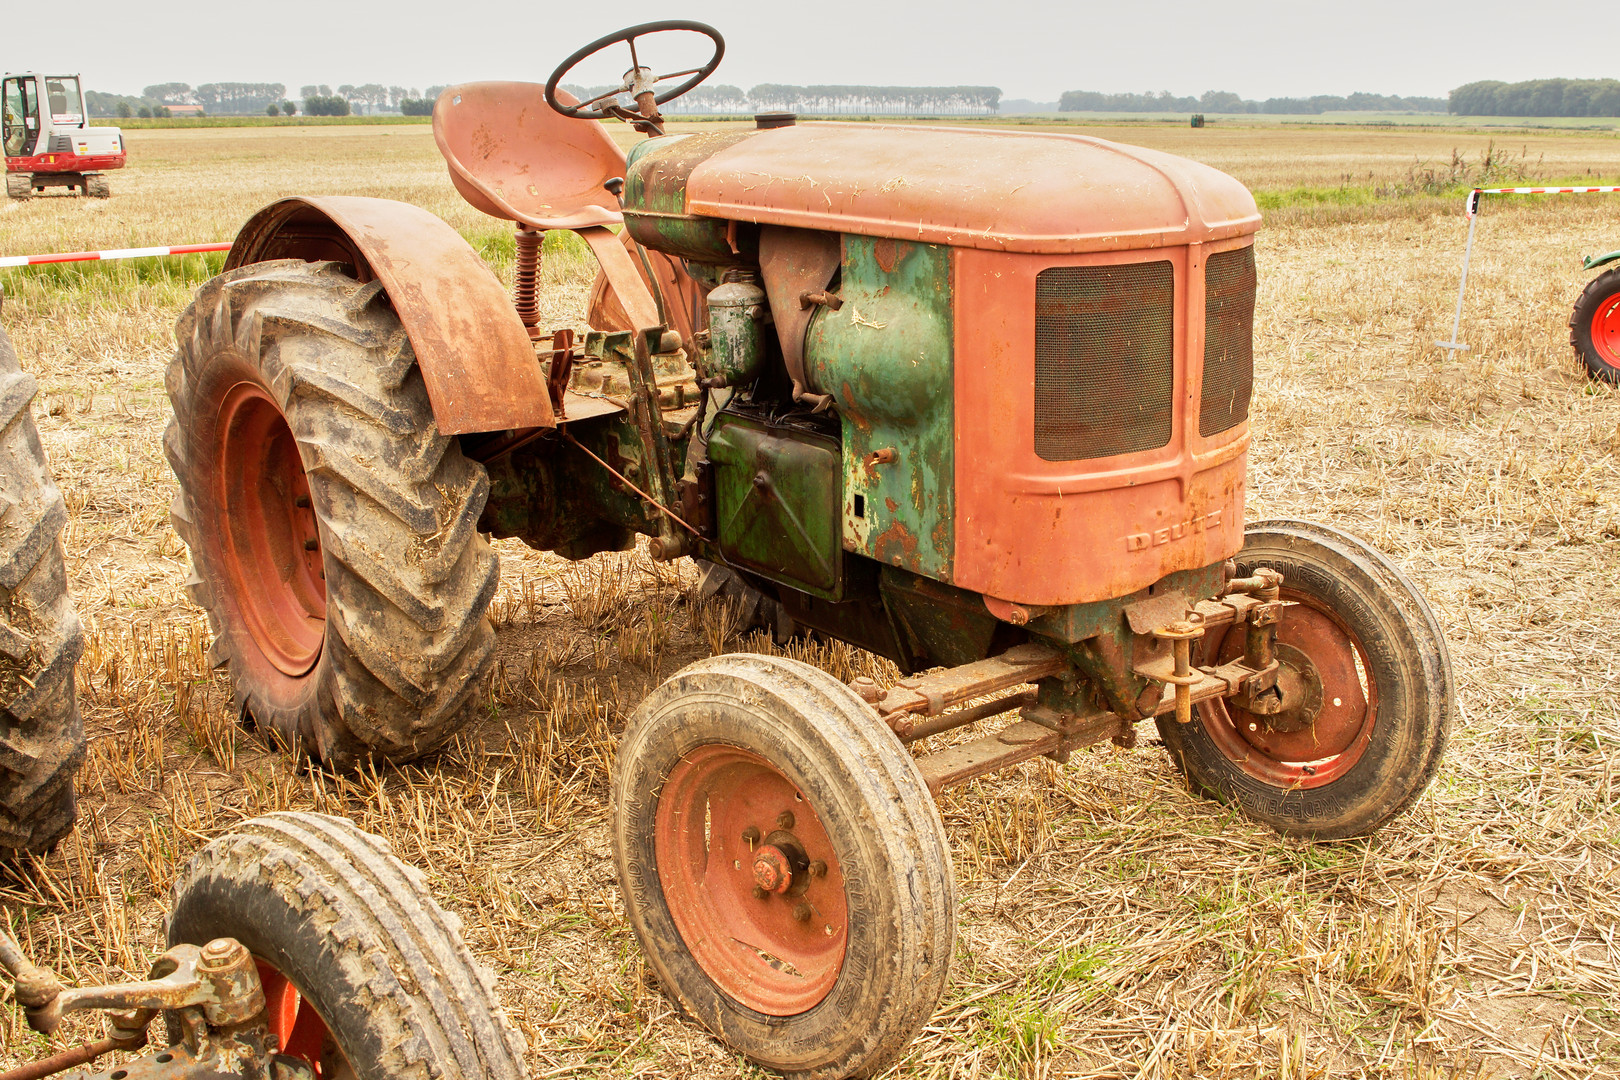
952, 241, 1249, 607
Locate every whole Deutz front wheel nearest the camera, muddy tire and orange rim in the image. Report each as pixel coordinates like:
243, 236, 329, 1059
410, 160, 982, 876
612, 654, 956, 1077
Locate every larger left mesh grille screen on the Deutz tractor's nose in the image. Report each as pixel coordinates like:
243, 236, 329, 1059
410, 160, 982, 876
1035, 262, 1176, 461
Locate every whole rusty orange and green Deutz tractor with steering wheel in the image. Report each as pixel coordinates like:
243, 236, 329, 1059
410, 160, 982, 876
165, 23, 1453, 1077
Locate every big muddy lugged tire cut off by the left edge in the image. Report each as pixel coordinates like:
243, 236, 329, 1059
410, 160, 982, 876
0, 320, 84, 853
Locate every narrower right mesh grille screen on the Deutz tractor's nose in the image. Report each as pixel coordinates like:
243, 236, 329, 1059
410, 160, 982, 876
1199, 248, 1254, 439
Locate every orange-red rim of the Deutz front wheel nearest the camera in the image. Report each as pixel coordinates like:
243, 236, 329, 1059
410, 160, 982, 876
653, 745, 849, 1017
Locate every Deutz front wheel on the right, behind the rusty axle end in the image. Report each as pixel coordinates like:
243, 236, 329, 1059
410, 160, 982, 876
1158, 521, 1453, 840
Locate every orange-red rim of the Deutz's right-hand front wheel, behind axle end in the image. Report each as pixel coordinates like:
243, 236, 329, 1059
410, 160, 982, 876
1199, 589, 1379, 789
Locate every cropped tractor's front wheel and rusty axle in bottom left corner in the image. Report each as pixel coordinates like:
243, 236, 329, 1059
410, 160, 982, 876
0, 813, 528, 1080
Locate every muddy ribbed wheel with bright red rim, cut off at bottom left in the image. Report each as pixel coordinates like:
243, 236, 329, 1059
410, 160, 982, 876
168, 813, 527, 1080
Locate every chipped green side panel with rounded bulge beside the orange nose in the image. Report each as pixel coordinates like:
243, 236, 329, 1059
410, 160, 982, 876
805, 236, 956, 581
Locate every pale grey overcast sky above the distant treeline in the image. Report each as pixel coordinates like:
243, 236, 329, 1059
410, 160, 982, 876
12, 0, 1620, 100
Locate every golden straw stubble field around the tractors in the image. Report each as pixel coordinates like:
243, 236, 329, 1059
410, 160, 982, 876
0, 126, 1620, 1078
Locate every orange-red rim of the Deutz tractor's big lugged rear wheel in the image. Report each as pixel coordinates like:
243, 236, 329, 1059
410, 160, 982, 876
214, 382, 326, 678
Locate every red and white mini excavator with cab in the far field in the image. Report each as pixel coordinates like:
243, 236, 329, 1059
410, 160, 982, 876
0, 73, 125, 199
